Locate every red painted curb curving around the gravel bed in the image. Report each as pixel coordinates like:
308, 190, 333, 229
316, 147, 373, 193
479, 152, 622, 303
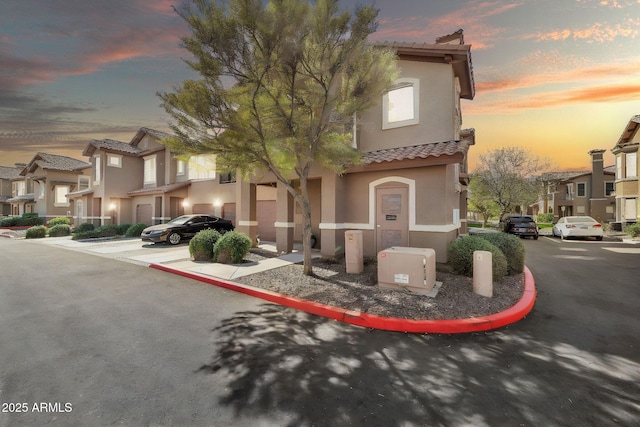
149, 264, 536, 334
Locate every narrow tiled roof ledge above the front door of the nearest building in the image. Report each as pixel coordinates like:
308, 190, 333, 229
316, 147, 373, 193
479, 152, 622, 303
362, 139, 471, 165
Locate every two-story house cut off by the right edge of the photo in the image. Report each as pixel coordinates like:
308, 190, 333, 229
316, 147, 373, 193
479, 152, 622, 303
611, 115, 640, 229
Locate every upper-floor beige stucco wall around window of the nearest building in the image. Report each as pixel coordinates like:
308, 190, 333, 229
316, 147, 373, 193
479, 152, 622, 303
358, 60, 459, 151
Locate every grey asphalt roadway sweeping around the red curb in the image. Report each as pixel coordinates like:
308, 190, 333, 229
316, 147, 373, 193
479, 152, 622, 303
0, 238, 640, 426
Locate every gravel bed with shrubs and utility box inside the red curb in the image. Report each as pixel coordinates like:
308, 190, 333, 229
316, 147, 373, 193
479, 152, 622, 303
234, 249, 524, 320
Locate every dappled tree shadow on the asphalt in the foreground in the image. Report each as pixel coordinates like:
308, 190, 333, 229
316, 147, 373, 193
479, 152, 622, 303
199, 304, 640, 426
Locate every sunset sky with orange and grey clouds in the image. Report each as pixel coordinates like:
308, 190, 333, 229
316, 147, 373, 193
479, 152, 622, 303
0, 0, 640, 170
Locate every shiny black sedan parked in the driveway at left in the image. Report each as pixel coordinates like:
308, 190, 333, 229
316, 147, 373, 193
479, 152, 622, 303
141, 215, 234, 245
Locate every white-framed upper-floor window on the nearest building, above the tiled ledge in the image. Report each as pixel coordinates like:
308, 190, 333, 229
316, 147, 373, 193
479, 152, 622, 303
382, 78, 420, 129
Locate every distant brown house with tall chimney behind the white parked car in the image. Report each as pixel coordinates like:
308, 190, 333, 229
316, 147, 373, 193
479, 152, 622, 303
529, 150, 615, 223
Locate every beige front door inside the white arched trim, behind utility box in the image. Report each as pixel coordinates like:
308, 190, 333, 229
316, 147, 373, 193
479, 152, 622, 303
376, 187, 409, 252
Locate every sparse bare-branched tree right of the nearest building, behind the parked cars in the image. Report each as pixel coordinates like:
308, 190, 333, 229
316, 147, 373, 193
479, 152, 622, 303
471, 147, 548, 219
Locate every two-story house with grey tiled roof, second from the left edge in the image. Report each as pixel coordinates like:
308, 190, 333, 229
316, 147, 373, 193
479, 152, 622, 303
20, 153, 91, 221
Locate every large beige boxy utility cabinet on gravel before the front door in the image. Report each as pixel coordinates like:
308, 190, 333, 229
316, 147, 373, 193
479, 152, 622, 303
378, 246, 436, 294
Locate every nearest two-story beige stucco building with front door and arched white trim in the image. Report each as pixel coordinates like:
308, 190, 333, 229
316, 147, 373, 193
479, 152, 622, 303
236, 31, 475, 262
